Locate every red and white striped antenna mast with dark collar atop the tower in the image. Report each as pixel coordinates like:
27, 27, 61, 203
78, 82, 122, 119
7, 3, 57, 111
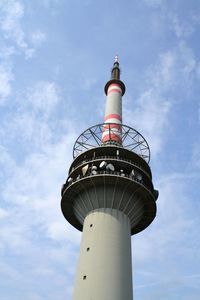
102, 55, 125, 145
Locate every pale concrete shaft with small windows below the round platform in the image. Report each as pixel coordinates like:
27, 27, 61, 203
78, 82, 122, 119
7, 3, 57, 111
73, 208, 133, 300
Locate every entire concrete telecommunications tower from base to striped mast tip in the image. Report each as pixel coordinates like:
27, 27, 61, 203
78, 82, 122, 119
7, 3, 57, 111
61, 59, 158, 300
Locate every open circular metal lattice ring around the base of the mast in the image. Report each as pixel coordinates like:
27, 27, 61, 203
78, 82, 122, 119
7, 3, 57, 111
73, 123, 150, 163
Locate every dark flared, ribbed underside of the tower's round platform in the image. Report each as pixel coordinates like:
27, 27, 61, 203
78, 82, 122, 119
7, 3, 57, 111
61, 174, 156, 234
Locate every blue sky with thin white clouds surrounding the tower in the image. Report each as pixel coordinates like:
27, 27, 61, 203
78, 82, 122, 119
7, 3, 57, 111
0, 0, 200, 300
